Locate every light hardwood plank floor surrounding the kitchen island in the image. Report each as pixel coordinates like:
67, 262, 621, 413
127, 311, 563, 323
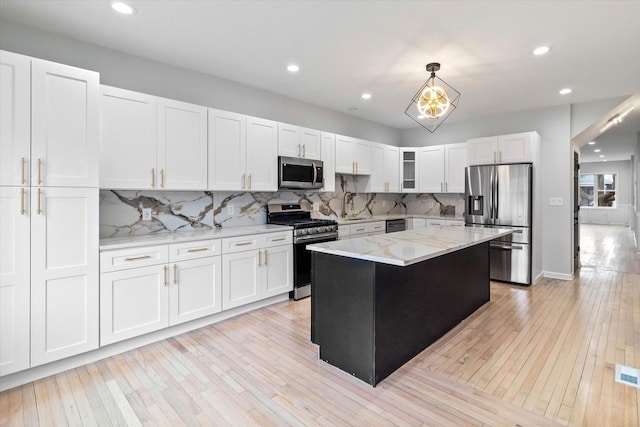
0, 226, 640, 426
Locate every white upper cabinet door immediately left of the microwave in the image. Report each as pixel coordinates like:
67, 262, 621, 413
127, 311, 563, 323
245, 117, 278, 191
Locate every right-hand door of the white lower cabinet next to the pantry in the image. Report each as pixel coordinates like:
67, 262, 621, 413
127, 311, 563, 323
169, 256, 222, 325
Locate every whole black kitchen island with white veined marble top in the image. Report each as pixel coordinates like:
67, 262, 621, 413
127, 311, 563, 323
307, 226, 511, 386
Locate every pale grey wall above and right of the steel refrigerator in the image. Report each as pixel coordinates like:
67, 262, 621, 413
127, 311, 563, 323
400, 105, 573, 279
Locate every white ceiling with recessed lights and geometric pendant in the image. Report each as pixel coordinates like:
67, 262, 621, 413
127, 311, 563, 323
0, 0, 640, 157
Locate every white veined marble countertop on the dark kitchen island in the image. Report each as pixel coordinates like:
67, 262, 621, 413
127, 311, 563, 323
307, 226, 513, 267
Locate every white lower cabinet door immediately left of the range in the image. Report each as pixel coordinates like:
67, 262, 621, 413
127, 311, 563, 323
262, 245, 293, 298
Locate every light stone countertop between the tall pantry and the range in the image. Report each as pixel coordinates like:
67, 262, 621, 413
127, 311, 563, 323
100, 224, 292, 251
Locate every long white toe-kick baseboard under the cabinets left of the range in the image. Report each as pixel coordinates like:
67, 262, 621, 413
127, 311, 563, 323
0, 292, 289, 392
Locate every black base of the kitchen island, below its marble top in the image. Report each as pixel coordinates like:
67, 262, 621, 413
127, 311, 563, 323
311, 243, 489, 386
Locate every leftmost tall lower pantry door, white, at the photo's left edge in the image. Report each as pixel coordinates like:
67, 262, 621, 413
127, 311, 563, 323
0, 187, 31, 376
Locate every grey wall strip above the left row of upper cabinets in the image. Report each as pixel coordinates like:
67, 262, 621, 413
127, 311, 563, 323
0, 21, 400, 145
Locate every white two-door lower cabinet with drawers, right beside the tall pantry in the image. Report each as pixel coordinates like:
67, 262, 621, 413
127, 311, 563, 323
100, 239, 222, 345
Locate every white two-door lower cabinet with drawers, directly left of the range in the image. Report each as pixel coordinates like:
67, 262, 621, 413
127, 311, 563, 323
222, 231, 293, 310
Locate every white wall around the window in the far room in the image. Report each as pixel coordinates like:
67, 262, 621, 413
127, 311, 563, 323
580, 160, 633, 226
